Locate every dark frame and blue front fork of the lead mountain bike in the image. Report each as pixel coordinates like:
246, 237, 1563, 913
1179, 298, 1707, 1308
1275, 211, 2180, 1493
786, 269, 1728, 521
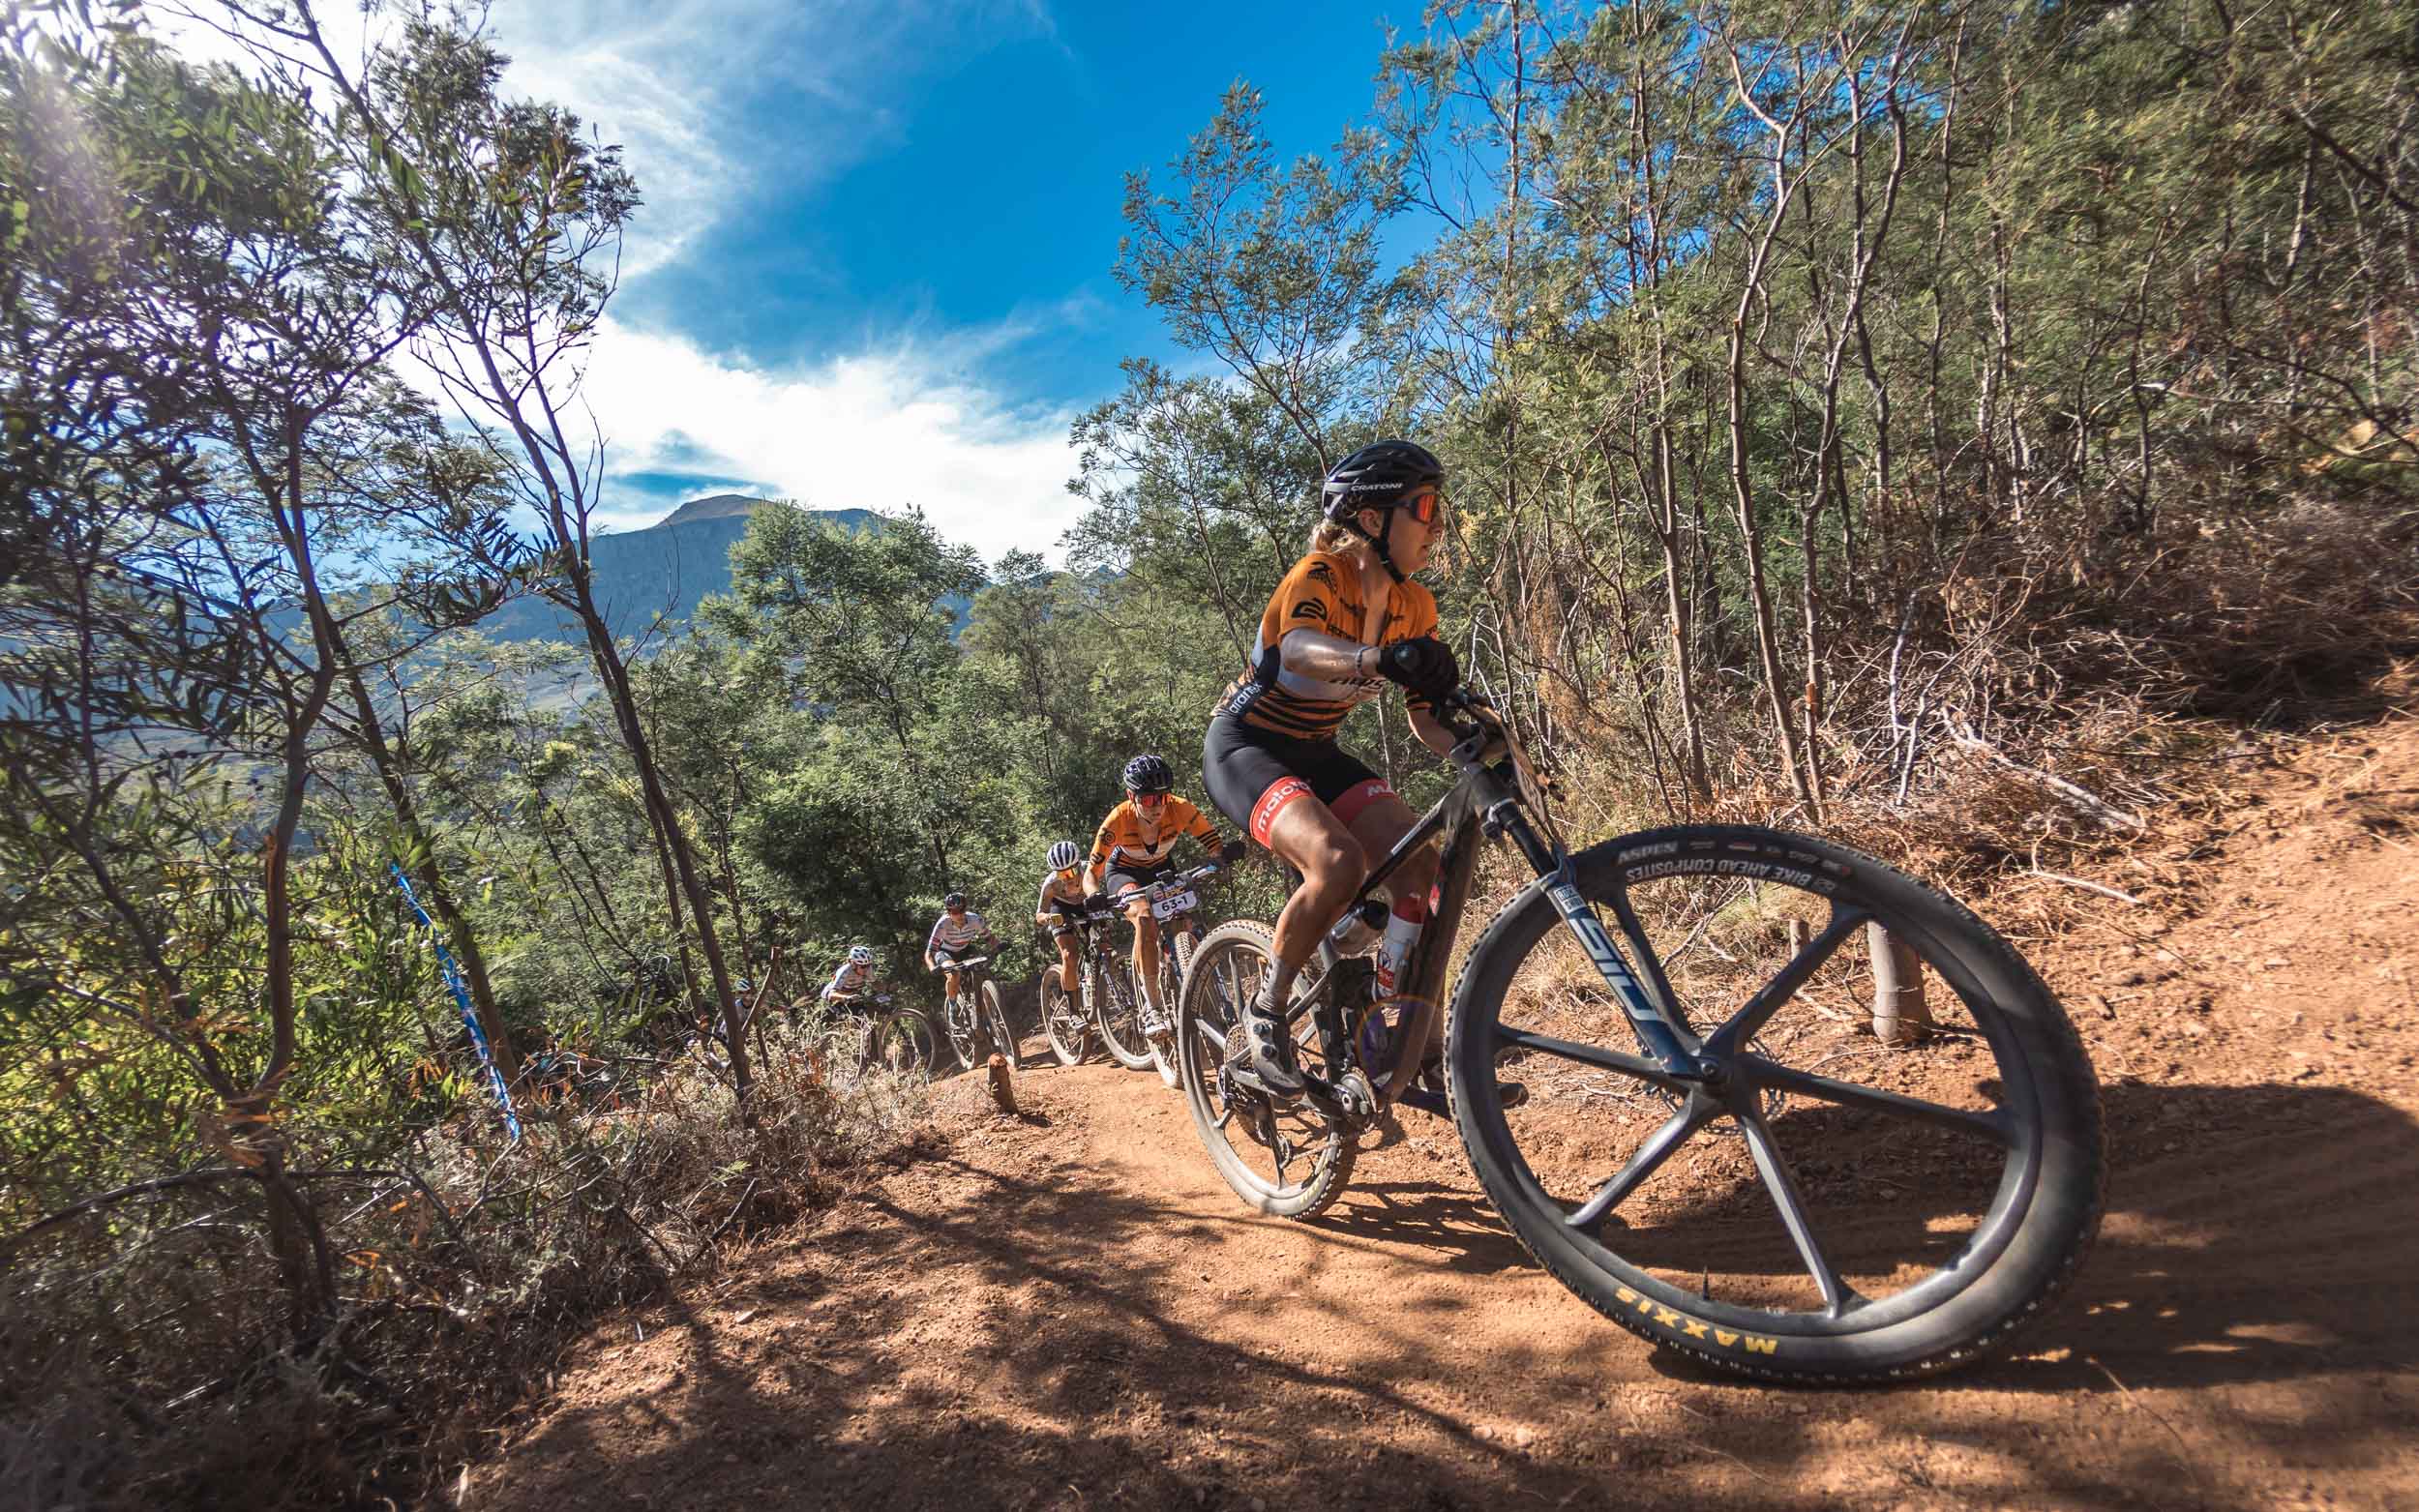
1287, 695, 1713, 1115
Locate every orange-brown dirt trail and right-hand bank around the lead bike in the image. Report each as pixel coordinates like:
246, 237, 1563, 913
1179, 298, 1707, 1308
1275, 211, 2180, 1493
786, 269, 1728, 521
460, 724, 2419, 1512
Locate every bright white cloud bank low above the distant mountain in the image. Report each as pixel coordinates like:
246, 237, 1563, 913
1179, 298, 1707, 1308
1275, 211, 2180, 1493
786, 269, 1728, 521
581, 322, 1084, 559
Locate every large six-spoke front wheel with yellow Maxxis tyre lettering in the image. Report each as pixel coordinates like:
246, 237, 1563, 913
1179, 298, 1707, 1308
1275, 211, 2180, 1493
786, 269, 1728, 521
1447, 825, 2105, 1381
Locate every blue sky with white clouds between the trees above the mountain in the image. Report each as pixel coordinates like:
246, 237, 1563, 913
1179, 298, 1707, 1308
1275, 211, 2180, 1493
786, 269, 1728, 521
455, 0, 1418, 556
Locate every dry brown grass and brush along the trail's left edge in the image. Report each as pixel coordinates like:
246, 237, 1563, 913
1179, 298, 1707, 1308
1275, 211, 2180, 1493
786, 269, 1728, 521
0, 1028, 929, 1512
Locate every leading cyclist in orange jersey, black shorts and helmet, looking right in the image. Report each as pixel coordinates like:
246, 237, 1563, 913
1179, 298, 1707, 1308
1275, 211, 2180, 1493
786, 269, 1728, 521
1203, 440, 1461, 1096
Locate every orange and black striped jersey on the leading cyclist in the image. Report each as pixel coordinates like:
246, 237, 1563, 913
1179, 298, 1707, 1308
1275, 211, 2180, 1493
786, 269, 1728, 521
1212, 551, 1437, 740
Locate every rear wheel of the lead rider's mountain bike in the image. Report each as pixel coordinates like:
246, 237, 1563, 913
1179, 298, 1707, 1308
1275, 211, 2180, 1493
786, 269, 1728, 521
1176, 919, 1355, 1219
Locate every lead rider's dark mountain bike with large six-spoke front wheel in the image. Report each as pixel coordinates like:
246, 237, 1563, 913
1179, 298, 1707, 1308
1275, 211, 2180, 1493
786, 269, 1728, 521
1179, 690, 2107, 1381
